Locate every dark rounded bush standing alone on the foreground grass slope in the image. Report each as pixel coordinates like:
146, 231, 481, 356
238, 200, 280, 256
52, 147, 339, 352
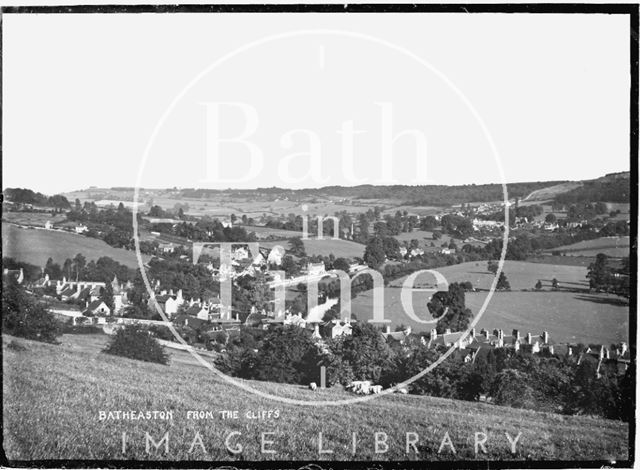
102, 325, 169, 365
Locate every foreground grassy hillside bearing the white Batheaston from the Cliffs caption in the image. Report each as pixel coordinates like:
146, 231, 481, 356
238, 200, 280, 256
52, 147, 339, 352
2, 335, 629, 467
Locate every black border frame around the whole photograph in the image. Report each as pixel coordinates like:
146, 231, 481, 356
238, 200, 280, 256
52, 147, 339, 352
0, 3, 640, 470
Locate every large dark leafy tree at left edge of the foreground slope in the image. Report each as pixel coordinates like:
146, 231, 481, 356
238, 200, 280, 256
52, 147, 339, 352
2, 280, 61, 343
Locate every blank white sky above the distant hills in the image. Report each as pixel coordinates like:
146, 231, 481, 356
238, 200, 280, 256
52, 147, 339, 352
2, 13, 630, 194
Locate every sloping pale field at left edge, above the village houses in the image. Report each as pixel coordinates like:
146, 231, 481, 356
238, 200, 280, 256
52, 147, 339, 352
2, 223, 149, 269
